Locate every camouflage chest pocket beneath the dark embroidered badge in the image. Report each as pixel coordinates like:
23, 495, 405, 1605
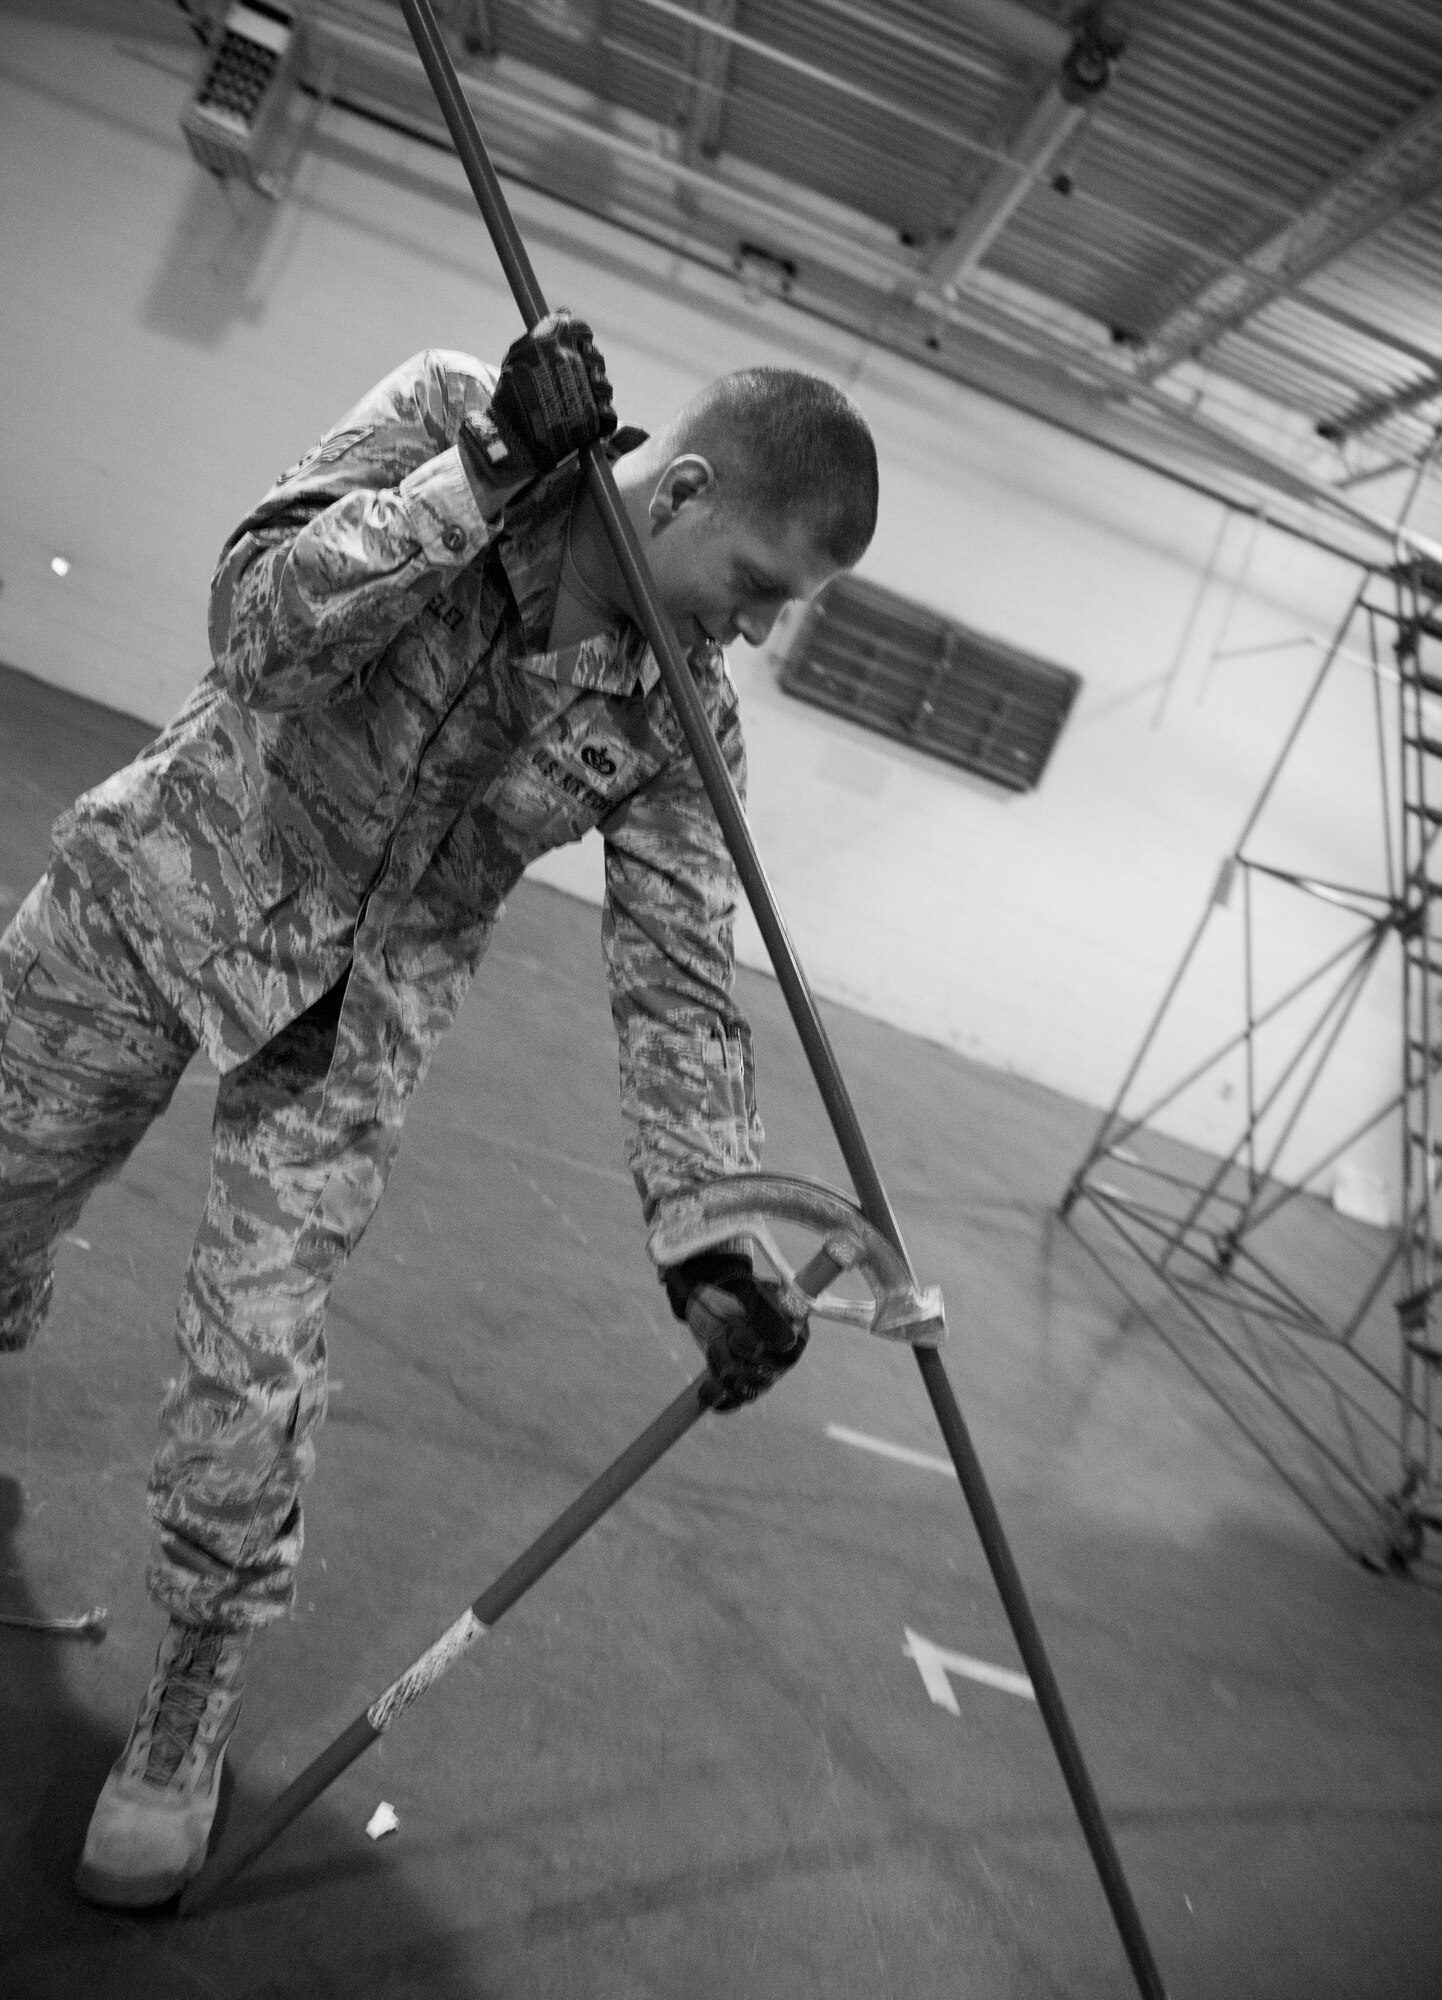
484, 694, 654, 852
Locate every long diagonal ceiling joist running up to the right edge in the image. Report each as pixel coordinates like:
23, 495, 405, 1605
1136, 92, 1442, 382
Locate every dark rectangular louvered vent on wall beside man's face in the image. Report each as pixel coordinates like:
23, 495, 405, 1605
780, 576, 1082, 792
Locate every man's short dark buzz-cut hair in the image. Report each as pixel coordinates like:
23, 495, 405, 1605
658, 368, 878, 570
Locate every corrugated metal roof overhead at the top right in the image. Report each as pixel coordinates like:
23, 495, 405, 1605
300, 0, 1442, 548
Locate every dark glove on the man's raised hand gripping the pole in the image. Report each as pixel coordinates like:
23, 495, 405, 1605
460, 312, 616, 486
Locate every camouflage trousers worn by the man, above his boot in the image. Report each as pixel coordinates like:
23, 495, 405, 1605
0, 858, 400, 1630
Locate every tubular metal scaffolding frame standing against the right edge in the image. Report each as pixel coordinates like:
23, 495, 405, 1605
1060, 520, 1442, 1574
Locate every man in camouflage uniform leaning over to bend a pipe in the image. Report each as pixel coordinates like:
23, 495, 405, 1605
0, 314, 876, 1904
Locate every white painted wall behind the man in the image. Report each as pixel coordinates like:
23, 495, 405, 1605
0, 0, 1396, 1200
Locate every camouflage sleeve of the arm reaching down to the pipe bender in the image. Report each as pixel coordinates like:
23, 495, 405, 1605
602, 708, 762, 1222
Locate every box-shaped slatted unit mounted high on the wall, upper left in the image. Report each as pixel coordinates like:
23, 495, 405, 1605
180, 0, 300, 194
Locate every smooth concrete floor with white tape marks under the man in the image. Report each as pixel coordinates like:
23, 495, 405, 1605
0, 672, 1442, 2000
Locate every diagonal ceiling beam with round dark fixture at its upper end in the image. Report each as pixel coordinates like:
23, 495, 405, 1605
926, 0, 1122, 296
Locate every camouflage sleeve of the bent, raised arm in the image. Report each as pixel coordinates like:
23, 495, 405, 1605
210, 350, 500, 710
